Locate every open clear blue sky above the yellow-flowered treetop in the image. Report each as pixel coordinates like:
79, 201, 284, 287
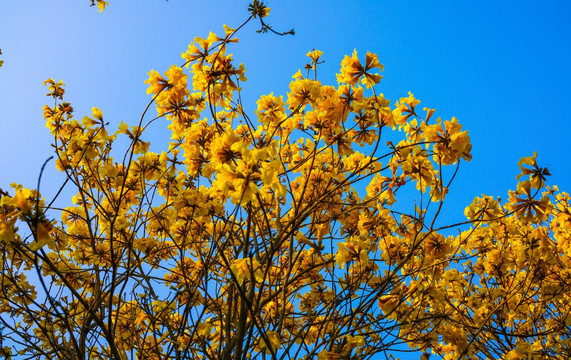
0, 0, 571, 220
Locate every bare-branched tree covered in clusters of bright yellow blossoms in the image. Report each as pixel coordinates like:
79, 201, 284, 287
0, 0, 571, 359
